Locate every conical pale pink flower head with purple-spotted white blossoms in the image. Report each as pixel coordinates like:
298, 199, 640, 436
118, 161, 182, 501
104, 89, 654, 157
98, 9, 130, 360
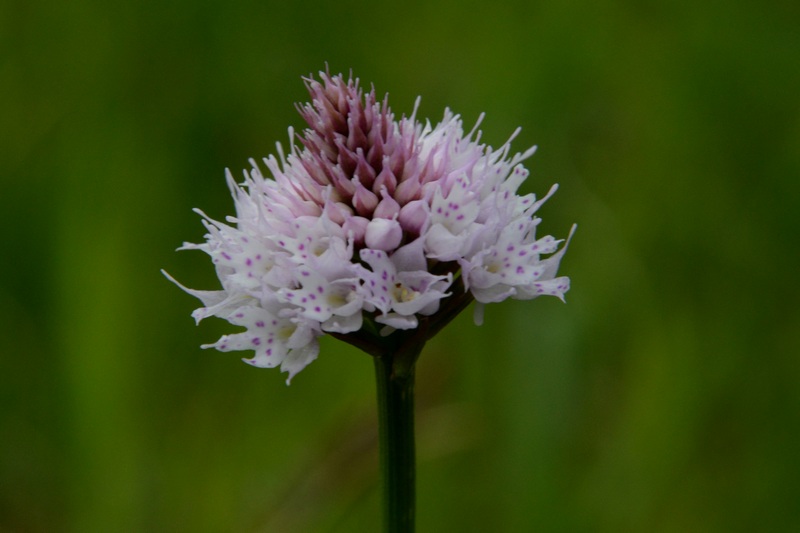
170, 72, 569, 382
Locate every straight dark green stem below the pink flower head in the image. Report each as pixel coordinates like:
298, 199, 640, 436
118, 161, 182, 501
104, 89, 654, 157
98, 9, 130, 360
373, 346, 422, 533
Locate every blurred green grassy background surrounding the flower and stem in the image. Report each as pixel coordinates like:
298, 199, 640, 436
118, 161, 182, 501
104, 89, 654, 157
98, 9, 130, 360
0, 0, 800, 533
